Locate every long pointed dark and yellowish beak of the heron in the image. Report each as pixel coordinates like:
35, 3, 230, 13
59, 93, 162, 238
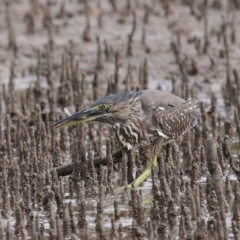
52, 108, 103, 128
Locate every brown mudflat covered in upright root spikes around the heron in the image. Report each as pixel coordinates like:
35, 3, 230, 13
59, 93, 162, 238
0, 0, 240, 239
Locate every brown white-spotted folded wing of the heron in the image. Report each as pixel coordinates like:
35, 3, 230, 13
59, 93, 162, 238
152, 99, 199, 139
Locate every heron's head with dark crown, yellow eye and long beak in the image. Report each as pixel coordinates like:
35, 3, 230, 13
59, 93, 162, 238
53, 92, 139, 128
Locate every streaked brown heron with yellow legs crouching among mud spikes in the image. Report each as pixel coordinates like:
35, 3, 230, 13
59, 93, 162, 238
53, 90, 198, 186
